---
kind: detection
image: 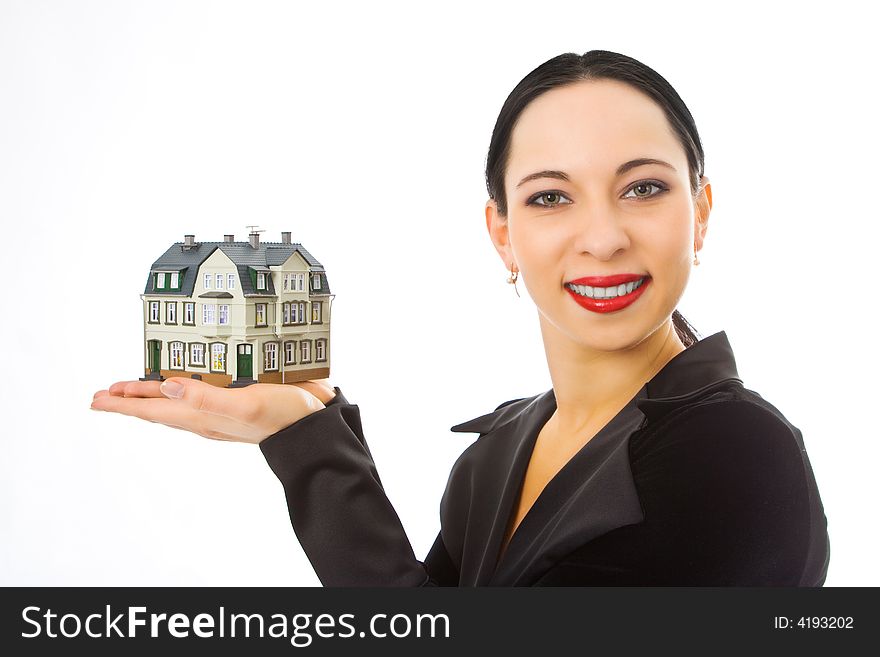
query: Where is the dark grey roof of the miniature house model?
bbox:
[144,242,330,297]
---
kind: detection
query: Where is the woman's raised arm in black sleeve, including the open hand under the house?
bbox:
[91,377,459,586]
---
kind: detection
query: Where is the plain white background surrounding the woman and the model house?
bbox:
[0,0,880,586]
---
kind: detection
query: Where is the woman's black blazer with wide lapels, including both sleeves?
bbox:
[260,331,830,586]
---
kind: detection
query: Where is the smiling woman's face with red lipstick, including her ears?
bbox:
[486,80,711,350]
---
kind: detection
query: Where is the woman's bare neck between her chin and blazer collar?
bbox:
[539,313,685,434]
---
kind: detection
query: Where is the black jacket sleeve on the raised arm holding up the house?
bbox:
[260,387,458,586]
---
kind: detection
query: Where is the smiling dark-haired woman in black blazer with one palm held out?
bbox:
[92,50,829,586]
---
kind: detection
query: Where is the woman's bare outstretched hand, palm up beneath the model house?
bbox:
[91,377,335,443]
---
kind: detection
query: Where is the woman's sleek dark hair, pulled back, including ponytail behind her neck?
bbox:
[486,50,704,347]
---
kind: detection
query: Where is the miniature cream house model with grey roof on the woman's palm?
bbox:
[141,232,333,387]
